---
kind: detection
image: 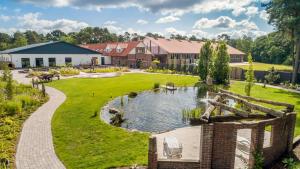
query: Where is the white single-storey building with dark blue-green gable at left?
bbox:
[0,41,111,68]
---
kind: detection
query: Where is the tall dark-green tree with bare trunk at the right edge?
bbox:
[266,0,300,83]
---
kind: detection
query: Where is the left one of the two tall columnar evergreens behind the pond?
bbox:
[198,41,213,81]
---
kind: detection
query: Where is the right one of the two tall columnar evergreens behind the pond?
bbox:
[213,42,230,84]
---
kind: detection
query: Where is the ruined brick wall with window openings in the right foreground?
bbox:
[149,113,296,169]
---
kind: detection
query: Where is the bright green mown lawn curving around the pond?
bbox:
[49,74,300,169]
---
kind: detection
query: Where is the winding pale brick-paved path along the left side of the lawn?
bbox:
[13,72,66,169]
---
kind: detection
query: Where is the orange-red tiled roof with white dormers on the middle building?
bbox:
[81,41,142,57]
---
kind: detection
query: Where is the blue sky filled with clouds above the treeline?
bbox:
[0,0,274,39]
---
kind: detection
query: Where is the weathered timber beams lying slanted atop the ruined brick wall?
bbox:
[199,89,294,124]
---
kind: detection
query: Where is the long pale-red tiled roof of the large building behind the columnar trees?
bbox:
[146,37,244,55]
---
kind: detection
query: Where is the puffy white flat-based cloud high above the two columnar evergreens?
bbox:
[193,16,236,29]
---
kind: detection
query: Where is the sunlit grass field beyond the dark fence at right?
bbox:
[232,62,293,72]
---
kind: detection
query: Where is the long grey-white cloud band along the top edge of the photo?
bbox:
[14,0,258,16]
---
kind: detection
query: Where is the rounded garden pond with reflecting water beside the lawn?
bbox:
[101,87,223,132]
